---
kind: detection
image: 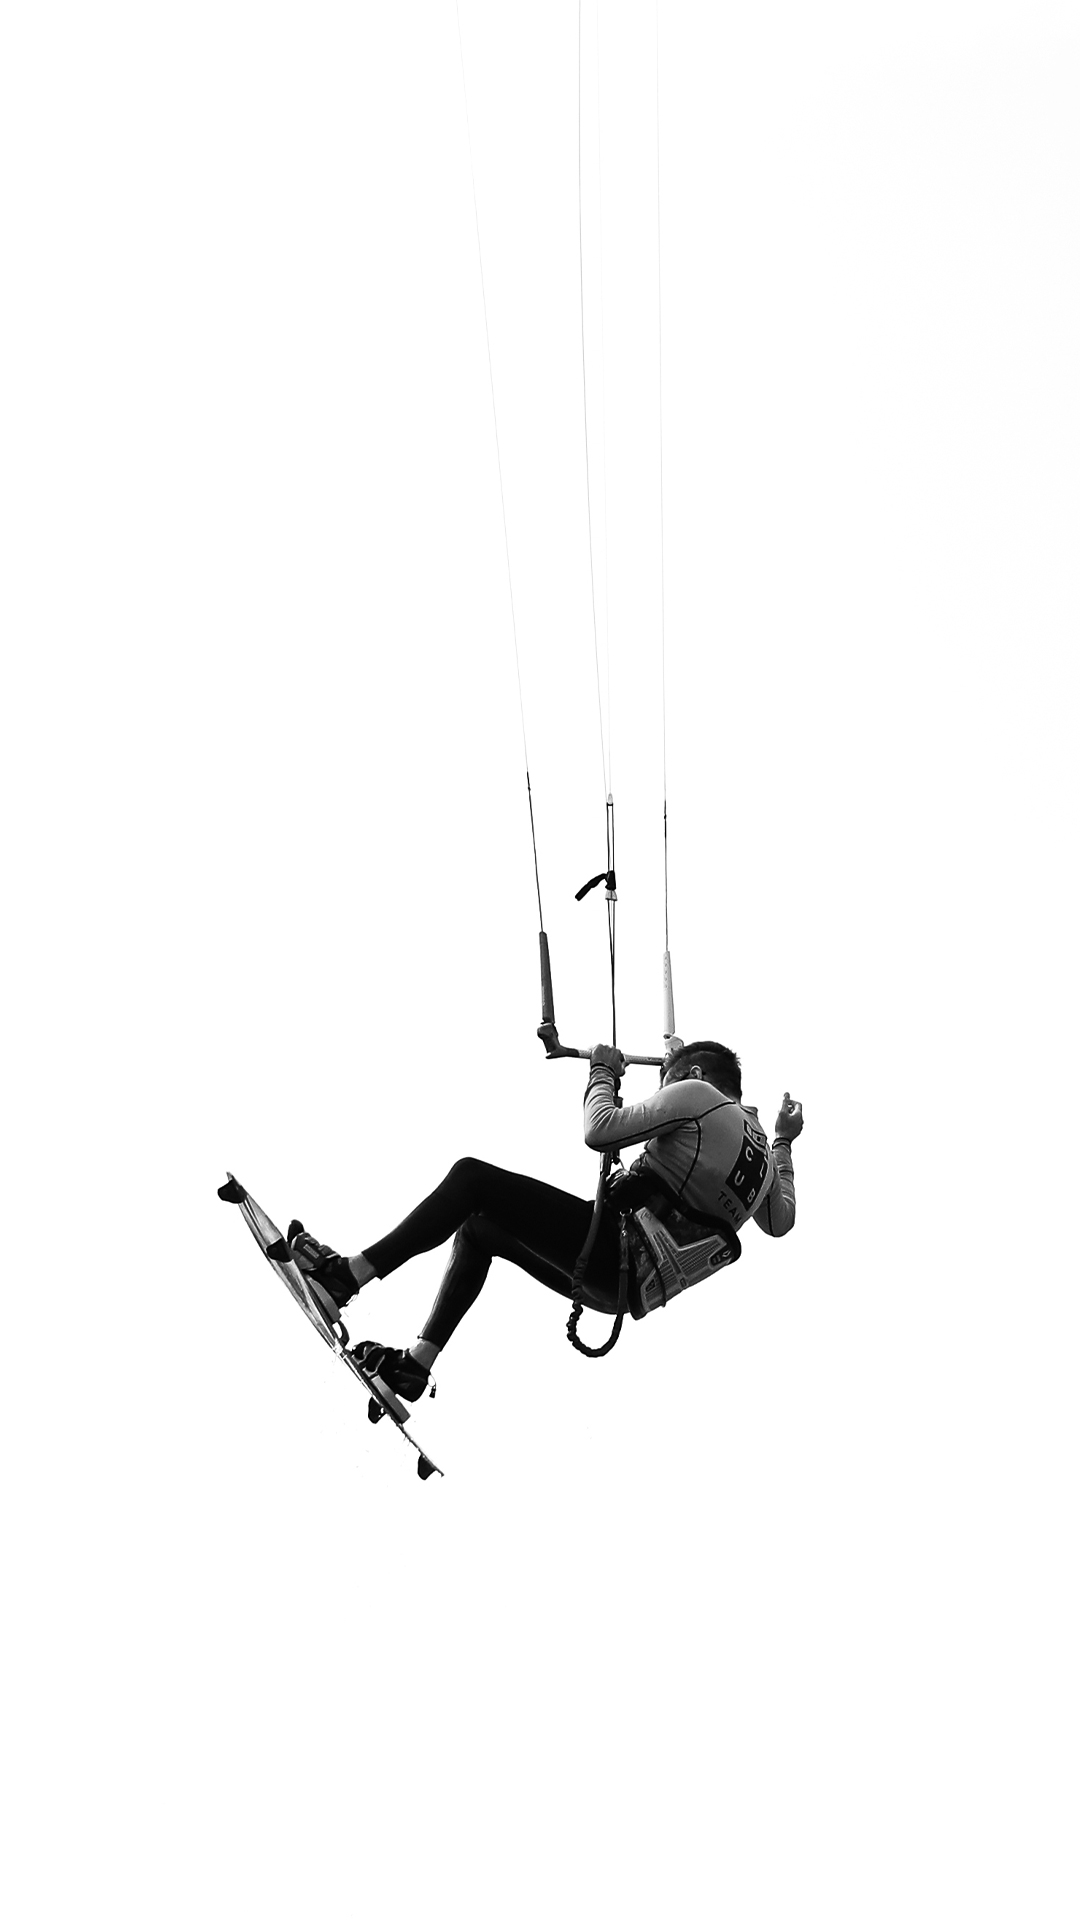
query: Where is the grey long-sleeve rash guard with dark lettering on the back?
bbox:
[584,1066,796,1236]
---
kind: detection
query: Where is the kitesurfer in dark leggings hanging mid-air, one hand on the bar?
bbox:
[288,1041,803,1400]
